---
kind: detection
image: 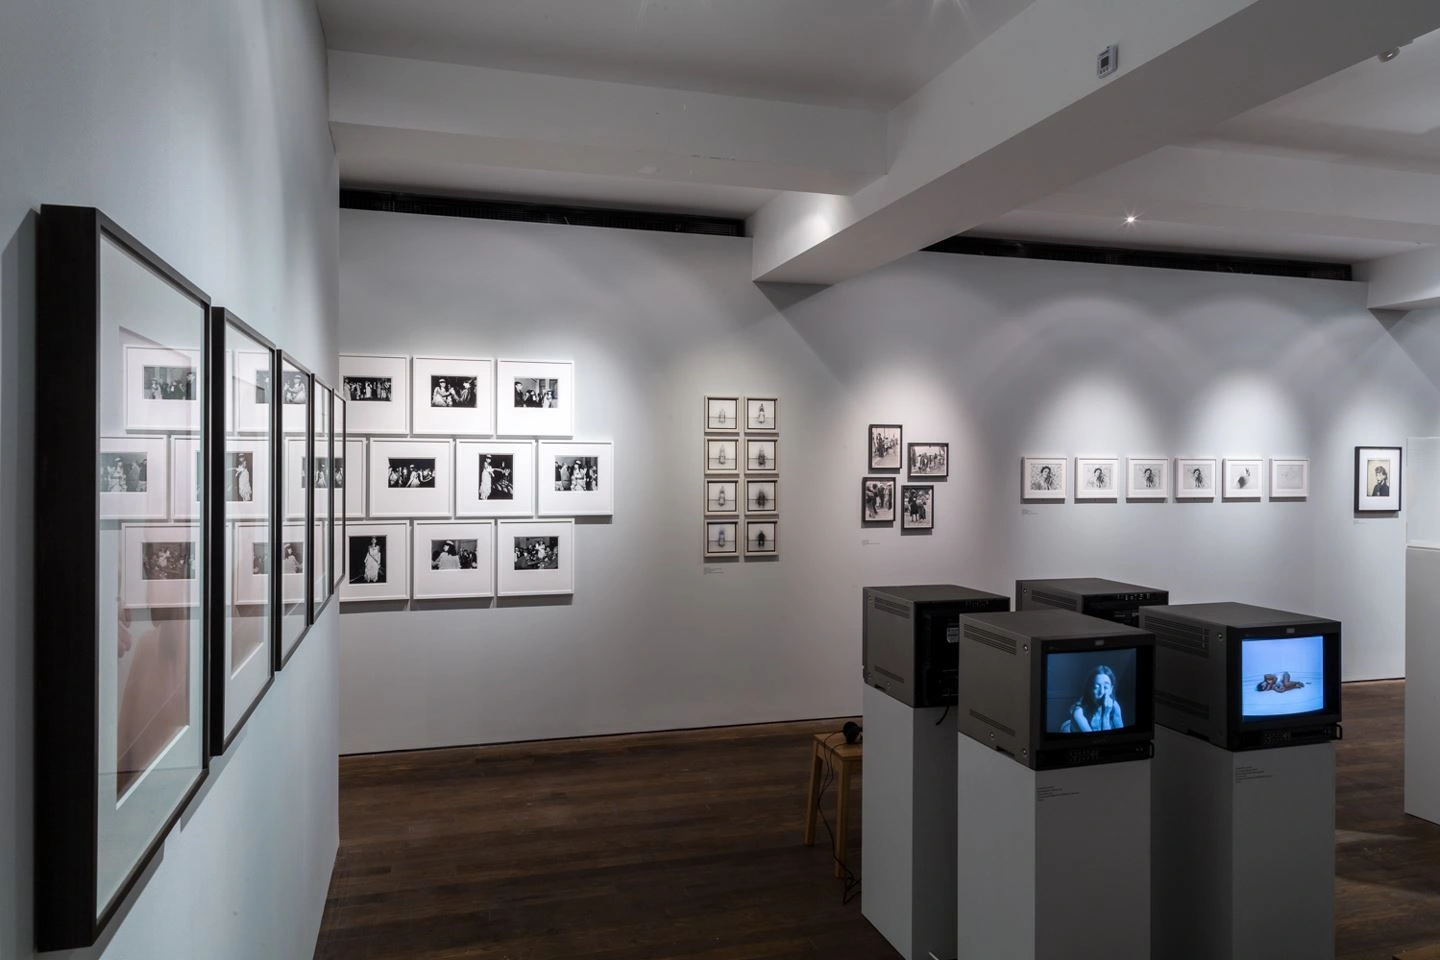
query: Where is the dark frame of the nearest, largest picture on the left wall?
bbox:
[35,204,216,953]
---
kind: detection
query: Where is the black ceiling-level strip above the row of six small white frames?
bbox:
[924,236,1354,281]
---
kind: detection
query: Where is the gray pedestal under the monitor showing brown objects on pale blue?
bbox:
[1152,727,1335,960]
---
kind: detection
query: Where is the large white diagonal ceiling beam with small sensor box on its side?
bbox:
[750,0,1440,284]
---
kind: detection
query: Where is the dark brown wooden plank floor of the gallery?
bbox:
[315,682,1440,960]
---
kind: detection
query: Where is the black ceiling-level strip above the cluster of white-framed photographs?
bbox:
[340,187,744,236]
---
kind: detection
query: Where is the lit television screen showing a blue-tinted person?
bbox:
[1045,649,1138,734]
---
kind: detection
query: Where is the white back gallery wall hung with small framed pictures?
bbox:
[340,210,1440,753]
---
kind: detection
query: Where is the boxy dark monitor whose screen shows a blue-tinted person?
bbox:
[958,610,1155,770]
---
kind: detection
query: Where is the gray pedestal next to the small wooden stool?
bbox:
[860,687,955,960]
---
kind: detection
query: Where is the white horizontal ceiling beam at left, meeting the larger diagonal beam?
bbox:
[330,50,886,193]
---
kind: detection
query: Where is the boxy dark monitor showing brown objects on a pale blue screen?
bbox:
[1140,603,1341,750]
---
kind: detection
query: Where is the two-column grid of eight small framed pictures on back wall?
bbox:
[701,396,780,560]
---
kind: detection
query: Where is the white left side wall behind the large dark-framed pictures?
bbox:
[0,0,338,960]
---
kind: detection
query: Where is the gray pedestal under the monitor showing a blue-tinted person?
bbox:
[956,735,1146,960]
